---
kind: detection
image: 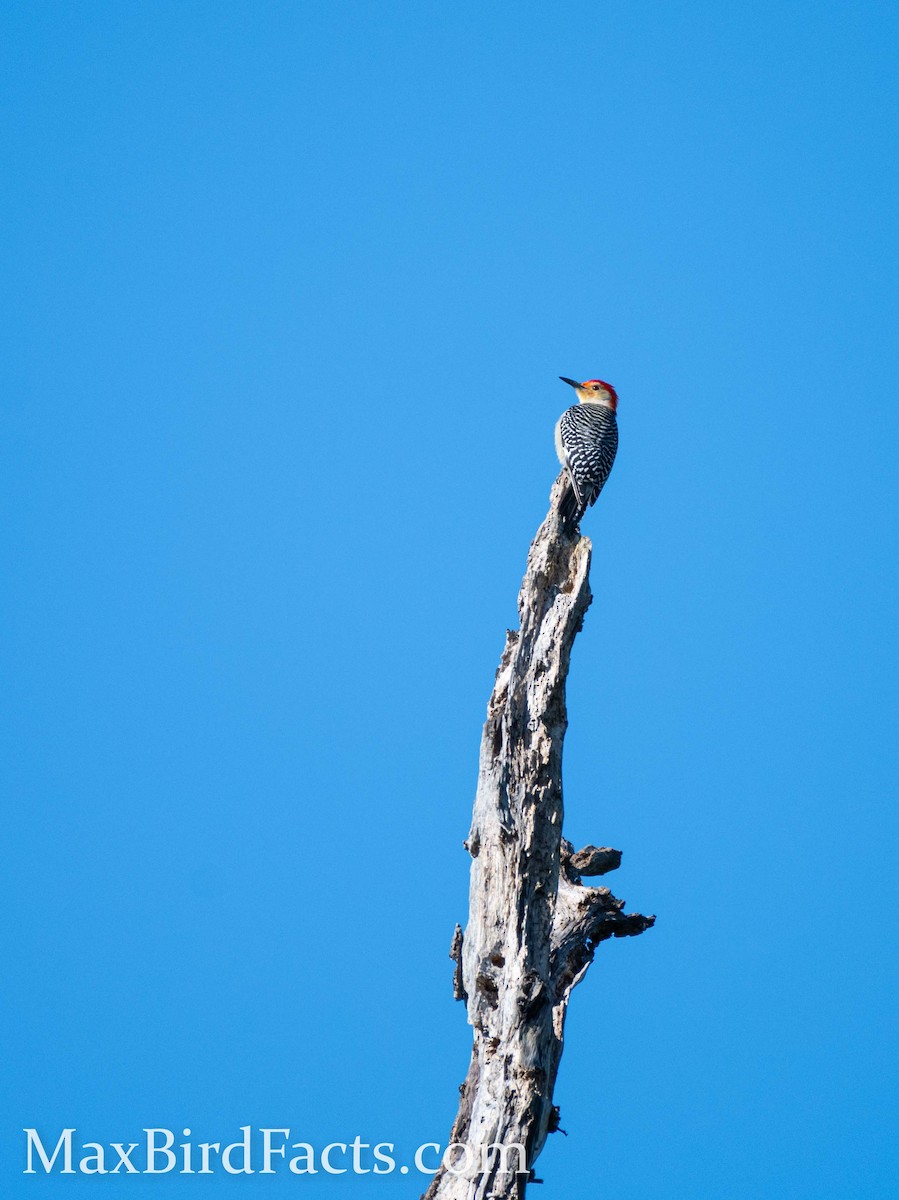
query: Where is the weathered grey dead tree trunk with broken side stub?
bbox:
[426,475,654,1200]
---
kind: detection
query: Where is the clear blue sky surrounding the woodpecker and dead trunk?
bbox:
[0,0,899,1200]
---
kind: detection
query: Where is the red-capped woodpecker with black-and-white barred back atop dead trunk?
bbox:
[556,376,618,534]
